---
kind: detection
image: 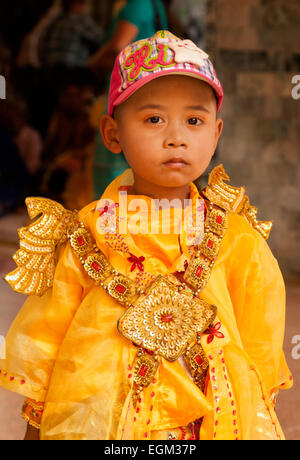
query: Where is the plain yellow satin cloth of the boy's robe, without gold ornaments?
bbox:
[0,170,292,440]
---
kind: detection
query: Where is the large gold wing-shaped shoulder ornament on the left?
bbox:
[4,197,79,296]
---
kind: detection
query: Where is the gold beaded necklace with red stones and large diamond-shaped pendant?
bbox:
[70,199,228,404]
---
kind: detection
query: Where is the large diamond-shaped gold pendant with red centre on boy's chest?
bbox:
[118,276,217,361]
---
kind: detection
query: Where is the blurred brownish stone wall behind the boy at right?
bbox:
[206,0,300,276]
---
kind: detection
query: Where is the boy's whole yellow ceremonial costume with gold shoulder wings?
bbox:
[0,167,292,440]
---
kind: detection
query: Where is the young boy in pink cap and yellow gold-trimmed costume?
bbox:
[0,31,292,440]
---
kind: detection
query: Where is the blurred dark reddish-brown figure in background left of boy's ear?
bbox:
[41,76,96,209]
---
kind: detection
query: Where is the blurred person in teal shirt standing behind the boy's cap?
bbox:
[89,0,169,197]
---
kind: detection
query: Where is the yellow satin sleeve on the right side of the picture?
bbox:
[229,215,292,397]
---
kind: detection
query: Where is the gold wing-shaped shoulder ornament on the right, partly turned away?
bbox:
[203,164,272,240]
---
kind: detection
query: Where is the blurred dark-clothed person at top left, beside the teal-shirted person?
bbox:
[39,0,104,137]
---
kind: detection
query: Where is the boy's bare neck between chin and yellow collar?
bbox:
[130,177,190,206]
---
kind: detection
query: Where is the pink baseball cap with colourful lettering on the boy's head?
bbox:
[108,30,224,115]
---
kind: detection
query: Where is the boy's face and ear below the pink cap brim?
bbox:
[101,75,223,193]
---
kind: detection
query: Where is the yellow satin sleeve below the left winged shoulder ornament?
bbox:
[0,242,87,402]
